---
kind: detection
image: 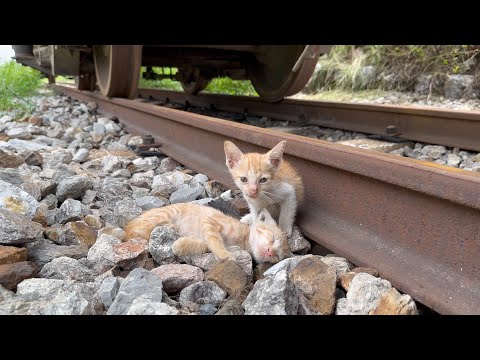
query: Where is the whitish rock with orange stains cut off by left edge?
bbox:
[0,180,38,219]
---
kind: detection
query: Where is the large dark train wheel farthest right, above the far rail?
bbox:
[247,45,321,102]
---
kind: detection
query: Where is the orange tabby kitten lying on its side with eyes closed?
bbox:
[125,203,293,263]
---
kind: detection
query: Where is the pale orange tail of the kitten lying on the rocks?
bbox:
[125,208,173,240]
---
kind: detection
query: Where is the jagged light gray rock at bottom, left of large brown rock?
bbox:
[246,270,299,315]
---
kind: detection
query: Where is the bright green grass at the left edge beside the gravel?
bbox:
[0,61,41,117]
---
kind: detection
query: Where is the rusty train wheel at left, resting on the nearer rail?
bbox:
[93,45,142,98]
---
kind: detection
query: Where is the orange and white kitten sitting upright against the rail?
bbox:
[224,141,304,237]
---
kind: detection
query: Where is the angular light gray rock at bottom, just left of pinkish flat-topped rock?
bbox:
[107,268,162,315]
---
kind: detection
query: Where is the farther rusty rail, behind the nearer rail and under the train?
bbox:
[139,89,480,151]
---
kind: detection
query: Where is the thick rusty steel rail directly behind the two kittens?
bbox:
[57,86,480,314]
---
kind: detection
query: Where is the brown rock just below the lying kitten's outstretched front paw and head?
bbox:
[205,260,251,302]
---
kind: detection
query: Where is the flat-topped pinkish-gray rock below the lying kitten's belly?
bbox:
[151,264,205,294]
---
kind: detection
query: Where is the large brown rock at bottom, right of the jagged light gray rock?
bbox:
[290,257,337,315]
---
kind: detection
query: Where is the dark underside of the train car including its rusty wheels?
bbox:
[13,45,331,102]
